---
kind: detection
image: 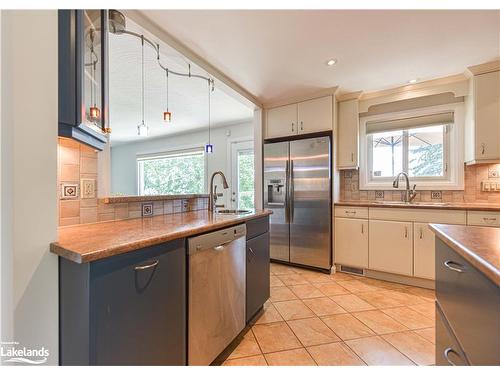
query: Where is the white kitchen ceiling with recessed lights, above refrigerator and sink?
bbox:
[141,10,500,103]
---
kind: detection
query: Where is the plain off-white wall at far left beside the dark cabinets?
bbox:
[1,10,58,365]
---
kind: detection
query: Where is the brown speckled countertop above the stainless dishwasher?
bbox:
[50,210,272,263]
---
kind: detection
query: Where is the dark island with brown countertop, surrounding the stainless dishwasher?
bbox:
[51,210,271,365]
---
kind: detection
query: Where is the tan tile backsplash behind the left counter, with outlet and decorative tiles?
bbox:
[57,138,208,226]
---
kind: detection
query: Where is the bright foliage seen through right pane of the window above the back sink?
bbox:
[409,143,443,176]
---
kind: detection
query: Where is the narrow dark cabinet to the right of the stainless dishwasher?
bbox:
[246,217,270,322]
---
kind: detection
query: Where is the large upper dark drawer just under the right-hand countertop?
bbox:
[436,239,500,365]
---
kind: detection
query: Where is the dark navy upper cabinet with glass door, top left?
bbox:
[58,9,109,150]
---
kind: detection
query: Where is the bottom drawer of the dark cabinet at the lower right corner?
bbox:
[436,303,469,366]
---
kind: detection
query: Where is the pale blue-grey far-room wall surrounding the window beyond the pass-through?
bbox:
[111,123,254,200]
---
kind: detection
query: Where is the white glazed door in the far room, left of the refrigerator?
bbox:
[230,141,255,210]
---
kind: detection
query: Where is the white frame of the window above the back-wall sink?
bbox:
[359,102,465,190]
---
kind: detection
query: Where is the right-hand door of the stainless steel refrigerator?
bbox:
[289,137,331,269]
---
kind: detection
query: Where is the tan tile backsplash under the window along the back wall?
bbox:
[340,164,500,204]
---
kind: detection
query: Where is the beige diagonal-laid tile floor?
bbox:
[223,263,435,366]
